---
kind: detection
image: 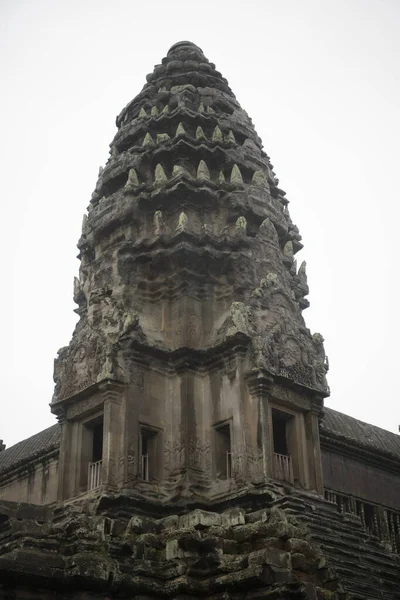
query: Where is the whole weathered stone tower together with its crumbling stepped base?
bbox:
[0,42,400,600]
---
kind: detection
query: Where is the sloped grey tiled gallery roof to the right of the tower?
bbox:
[321,408,400,460]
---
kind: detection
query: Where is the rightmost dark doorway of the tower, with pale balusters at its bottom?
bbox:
[272,409,295,484]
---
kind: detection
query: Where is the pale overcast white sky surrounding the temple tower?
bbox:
[0,0,400,446]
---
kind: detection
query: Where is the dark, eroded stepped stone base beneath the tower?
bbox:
[0,495,398,600]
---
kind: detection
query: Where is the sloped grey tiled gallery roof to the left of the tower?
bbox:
[0,423,60,474]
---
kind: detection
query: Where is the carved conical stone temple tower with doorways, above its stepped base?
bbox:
[52,42,329,505]
